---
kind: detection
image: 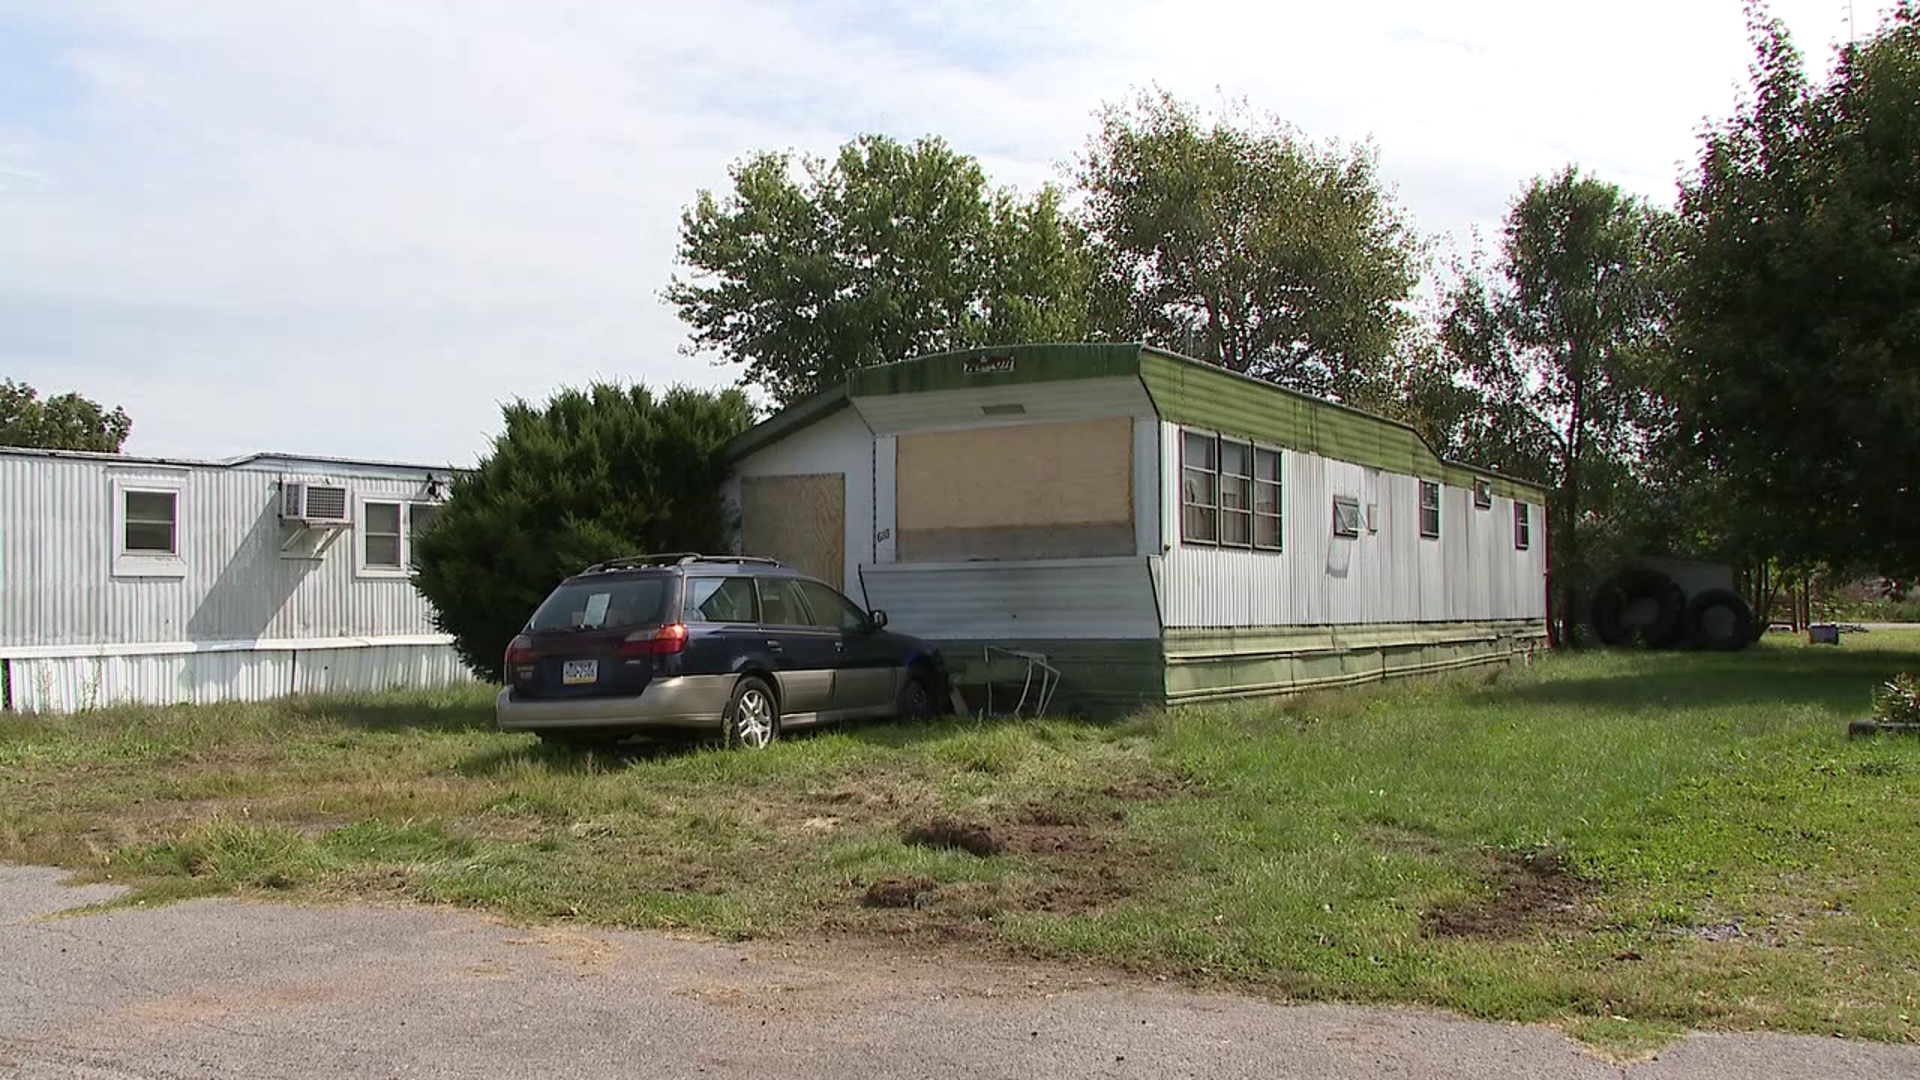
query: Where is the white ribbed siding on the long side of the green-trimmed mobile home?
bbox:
[1162,425,1546,626]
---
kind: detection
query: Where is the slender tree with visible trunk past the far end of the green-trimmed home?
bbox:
[1442,169,1668,640]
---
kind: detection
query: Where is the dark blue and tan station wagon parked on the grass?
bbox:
[493,553,947,748]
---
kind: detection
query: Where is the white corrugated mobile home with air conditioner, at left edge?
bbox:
[0,448,468,711]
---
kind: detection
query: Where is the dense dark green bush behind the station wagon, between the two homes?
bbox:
[413,384,753,680]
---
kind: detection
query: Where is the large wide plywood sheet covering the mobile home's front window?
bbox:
[895,417,1135,563]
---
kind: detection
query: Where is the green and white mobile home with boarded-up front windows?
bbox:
[730,344,1546,711]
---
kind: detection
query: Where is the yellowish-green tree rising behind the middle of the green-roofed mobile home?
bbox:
[1079,92,1421,398]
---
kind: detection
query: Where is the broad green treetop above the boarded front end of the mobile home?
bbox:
[664,135,1091,404]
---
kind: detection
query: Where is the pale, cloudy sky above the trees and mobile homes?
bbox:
[0,0,1876,465]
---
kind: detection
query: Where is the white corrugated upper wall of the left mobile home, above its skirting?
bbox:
[0,455,434,650]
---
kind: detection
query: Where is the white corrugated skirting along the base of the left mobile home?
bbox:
[10,646,472,713]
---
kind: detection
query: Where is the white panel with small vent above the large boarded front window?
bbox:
[856,375,1156,438]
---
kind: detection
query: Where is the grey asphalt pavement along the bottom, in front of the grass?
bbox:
[0,867,1920,1080]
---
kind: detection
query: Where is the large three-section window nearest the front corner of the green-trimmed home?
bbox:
[1181,430,1283,552]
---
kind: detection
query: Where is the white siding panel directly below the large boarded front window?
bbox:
[860,557,1160,640]
